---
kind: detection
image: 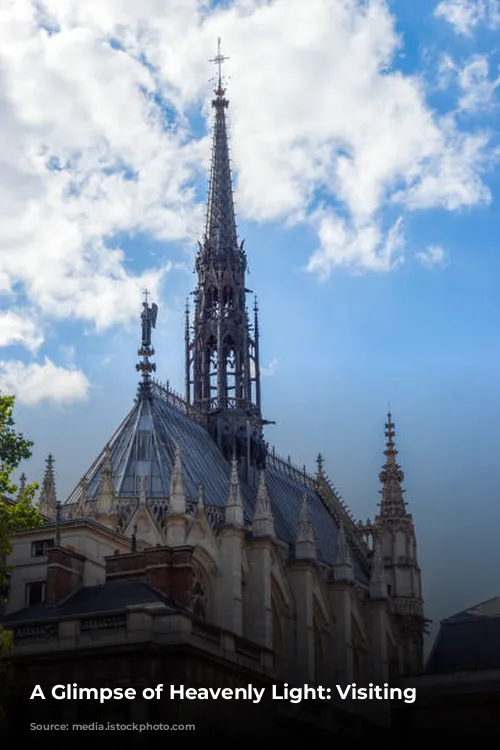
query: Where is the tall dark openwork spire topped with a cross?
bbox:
[186,40,266,485]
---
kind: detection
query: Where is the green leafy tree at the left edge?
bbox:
[0,395,43,659]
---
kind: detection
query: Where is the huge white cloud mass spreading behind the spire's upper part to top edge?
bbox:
[0,0,490,320]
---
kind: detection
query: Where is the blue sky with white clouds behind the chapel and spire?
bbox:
[0,0,500,648]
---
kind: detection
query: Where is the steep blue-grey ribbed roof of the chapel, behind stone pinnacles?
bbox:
[61,388,368,584]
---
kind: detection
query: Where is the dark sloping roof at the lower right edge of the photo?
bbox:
[425,597,500,675]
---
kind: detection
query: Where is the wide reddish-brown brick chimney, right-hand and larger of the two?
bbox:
[105,546,194,605]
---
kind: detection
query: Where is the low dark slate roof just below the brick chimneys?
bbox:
[1,580,179,626]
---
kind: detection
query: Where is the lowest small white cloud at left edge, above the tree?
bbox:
[0,358,90,406]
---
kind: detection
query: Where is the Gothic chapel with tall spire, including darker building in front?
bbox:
[1,42,425,748]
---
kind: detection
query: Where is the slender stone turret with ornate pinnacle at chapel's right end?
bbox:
[374,412,426,672]
